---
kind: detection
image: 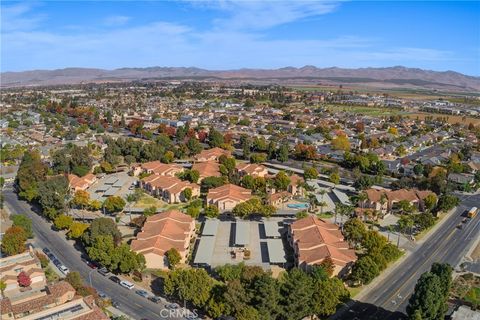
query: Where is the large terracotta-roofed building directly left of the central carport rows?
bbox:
[130,210,195,269]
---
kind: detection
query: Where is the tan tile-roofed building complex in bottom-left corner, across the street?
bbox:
[0,250,109,320]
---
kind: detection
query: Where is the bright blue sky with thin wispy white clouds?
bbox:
[1,0,480,76]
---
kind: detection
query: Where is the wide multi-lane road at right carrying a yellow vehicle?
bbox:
[332,195,480,320]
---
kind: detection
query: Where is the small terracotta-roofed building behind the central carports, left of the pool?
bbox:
[207,184,252,212]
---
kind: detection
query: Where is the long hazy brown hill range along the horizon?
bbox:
[0,66,480,92]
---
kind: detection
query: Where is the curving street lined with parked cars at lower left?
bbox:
[2,188,186,319]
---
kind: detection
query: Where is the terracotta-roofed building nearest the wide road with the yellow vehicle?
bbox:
[358,189,434,214]
